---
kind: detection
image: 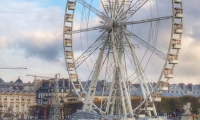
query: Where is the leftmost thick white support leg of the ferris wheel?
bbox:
[83,35,109,112]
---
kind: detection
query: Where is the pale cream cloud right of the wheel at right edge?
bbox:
[177,36,200,77]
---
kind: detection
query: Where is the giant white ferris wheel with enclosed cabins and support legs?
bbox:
[63,0,183,119]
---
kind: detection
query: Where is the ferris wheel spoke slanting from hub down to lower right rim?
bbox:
[125,30,167,60]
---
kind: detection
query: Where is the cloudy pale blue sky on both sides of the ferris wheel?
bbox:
[0,0,200,84]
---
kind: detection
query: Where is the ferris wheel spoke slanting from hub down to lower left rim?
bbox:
[71,31,106,68]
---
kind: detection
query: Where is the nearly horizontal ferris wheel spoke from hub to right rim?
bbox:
[120,16,173,25]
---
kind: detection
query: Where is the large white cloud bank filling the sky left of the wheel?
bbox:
[0,0,67,81]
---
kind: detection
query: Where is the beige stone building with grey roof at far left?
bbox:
[0,78,35,118]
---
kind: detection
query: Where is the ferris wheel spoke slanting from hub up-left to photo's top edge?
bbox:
[77,0,106,20]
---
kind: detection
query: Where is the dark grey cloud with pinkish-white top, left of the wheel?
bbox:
[13,31,64,61]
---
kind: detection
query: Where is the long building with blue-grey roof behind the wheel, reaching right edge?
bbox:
[82,81,200,100]
